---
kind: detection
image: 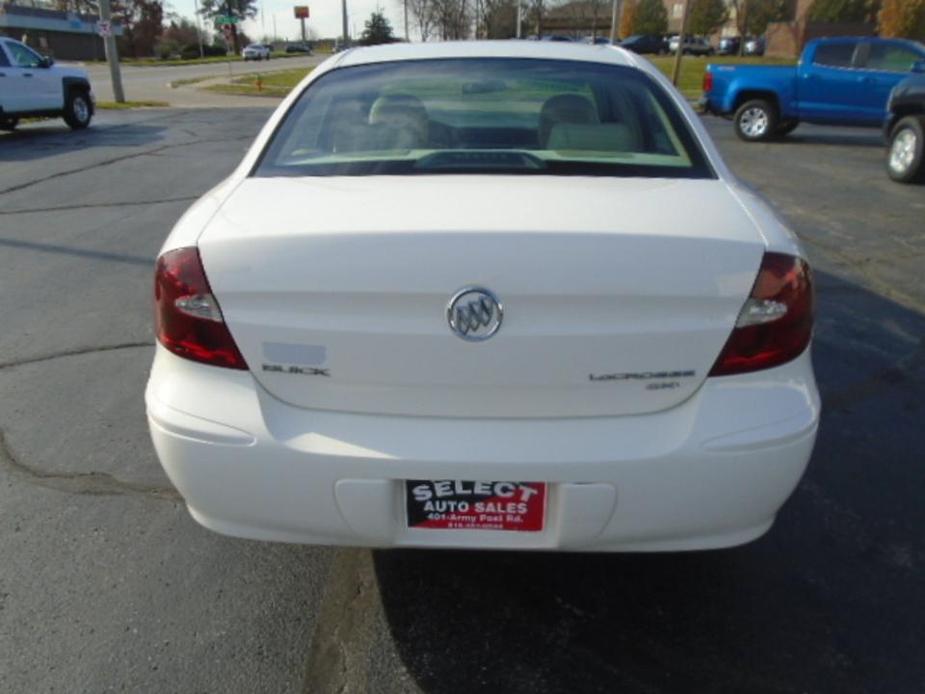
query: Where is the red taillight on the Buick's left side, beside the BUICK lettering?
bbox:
[154,248,247,369]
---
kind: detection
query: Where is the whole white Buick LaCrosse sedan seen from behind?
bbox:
[146,41,819,551]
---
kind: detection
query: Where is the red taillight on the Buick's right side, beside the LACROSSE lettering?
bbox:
[710,253,813,376]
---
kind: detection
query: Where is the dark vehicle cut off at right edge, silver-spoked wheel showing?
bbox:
[885,61,925,183]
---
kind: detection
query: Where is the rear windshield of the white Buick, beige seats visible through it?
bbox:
[255,58,713,178]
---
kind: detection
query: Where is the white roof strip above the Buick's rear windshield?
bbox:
[337,39,641,67]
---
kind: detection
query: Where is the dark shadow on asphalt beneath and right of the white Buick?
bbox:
[374,274,925,694]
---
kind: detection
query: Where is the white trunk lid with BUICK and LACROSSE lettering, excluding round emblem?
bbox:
[199,176,764,417]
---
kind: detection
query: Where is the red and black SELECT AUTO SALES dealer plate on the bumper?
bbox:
[405,480,546,532]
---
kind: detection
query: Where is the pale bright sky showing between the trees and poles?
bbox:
[170,0,405,40]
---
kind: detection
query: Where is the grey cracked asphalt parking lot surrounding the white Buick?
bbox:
[0,108,925,694]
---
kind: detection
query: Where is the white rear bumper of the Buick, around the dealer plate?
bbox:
[146,347,819,551]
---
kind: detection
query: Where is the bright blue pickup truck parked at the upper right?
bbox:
[701,37,925,142]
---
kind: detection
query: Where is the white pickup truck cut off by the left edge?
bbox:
[0,36,95,130]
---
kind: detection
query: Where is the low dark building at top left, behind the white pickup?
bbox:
[0,0,122,60]
